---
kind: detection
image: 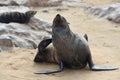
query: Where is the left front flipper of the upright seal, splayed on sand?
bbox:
[35,62,64,74]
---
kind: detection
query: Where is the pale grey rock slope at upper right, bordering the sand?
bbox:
[85,3,120,23]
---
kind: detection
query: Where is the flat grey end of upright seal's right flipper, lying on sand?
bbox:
[90,65,118,71]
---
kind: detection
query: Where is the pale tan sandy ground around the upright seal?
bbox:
[0,0,120,80]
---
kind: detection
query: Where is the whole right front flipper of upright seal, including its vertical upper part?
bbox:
[88,54,118,71]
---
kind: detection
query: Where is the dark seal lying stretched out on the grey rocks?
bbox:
[0,11,36,23]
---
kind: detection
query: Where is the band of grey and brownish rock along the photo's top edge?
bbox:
[0,0,86,7]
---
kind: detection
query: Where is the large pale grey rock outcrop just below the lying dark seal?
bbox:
[0,7,52,50]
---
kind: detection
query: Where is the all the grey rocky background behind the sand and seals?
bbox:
[0,0,120,51]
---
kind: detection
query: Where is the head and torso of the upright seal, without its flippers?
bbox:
[52,15,90,68]
